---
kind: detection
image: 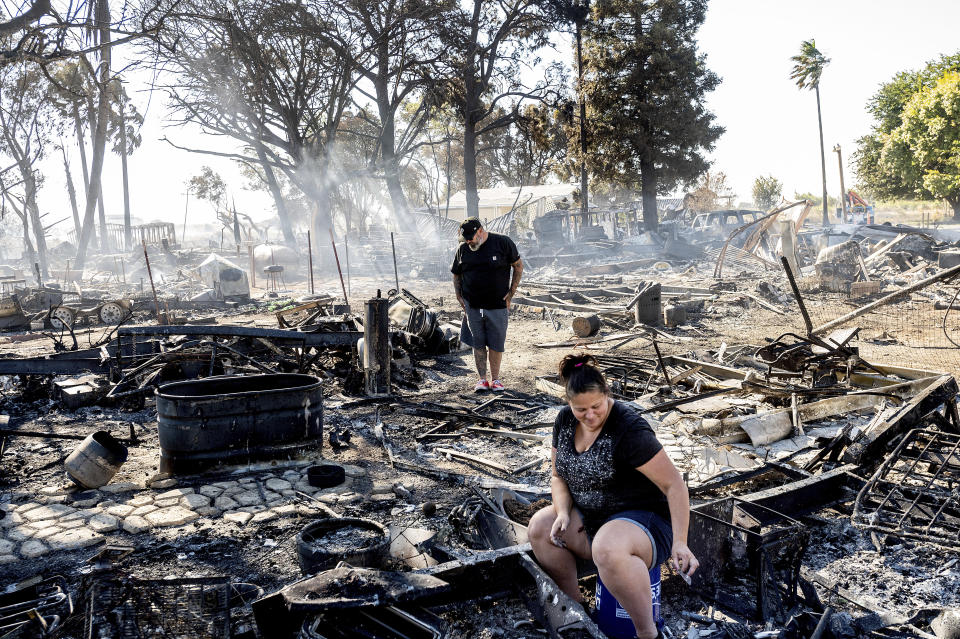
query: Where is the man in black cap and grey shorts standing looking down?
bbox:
[450,218,523,392]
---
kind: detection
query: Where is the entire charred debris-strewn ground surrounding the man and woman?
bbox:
[0,206,960,639]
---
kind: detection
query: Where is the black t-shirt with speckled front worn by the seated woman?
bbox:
[553,401,670,535]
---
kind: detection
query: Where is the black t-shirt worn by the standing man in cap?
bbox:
[450,233,520,308]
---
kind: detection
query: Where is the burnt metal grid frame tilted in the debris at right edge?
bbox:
[853,429,960,551]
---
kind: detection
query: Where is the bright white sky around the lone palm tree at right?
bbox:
[700,0,960,201]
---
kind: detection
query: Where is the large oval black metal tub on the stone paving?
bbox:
[156,374,323,473]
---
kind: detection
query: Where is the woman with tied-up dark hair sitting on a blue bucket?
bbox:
[528,355,700,639]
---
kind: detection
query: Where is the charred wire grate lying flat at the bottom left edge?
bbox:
[84,577,230,639]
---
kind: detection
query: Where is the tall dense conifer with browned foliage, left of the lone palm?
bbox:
[584,0,724,229]
